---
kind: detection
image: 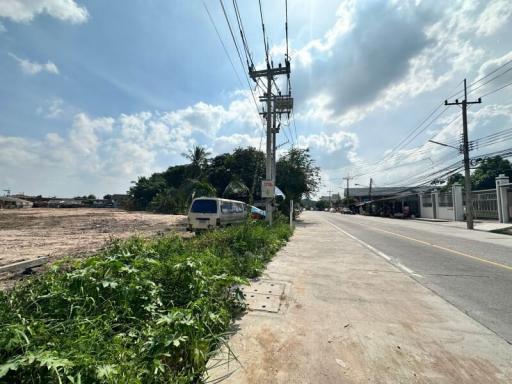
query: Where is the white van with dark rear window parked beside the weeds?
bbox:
[187,197,248,231]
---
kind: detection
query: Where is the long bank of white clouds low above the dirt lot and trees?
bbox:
[0,93,260,196]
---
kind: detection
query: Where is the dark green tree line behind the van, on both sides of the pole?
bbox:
[127,146,320,214]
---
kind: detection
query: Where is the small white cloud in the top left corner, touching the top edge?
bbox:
[0,0,89,24]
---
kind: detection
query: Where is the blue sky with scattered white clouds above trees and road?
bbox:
[0,0,512,196]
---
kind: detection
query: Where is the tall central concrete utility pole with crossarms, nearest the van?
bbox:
[249,58,293,224]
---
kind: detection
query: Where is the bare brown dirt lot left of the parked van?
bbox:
[0,208,186,266]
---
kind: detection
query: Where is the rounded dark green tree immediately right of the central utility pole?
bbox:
[276,148,320,214]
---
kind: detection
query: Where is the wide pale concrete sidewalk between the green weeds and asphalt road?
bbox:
[207,216,512,384]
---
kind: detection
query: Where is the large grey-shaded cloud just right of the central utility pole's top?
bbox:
[293,2,431,120]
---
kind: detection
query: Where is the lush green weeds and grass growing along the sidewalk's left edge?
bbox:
[0,222,291,384]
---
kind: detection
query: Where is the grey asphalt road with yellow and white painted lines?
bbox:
[322,212,512,344]
